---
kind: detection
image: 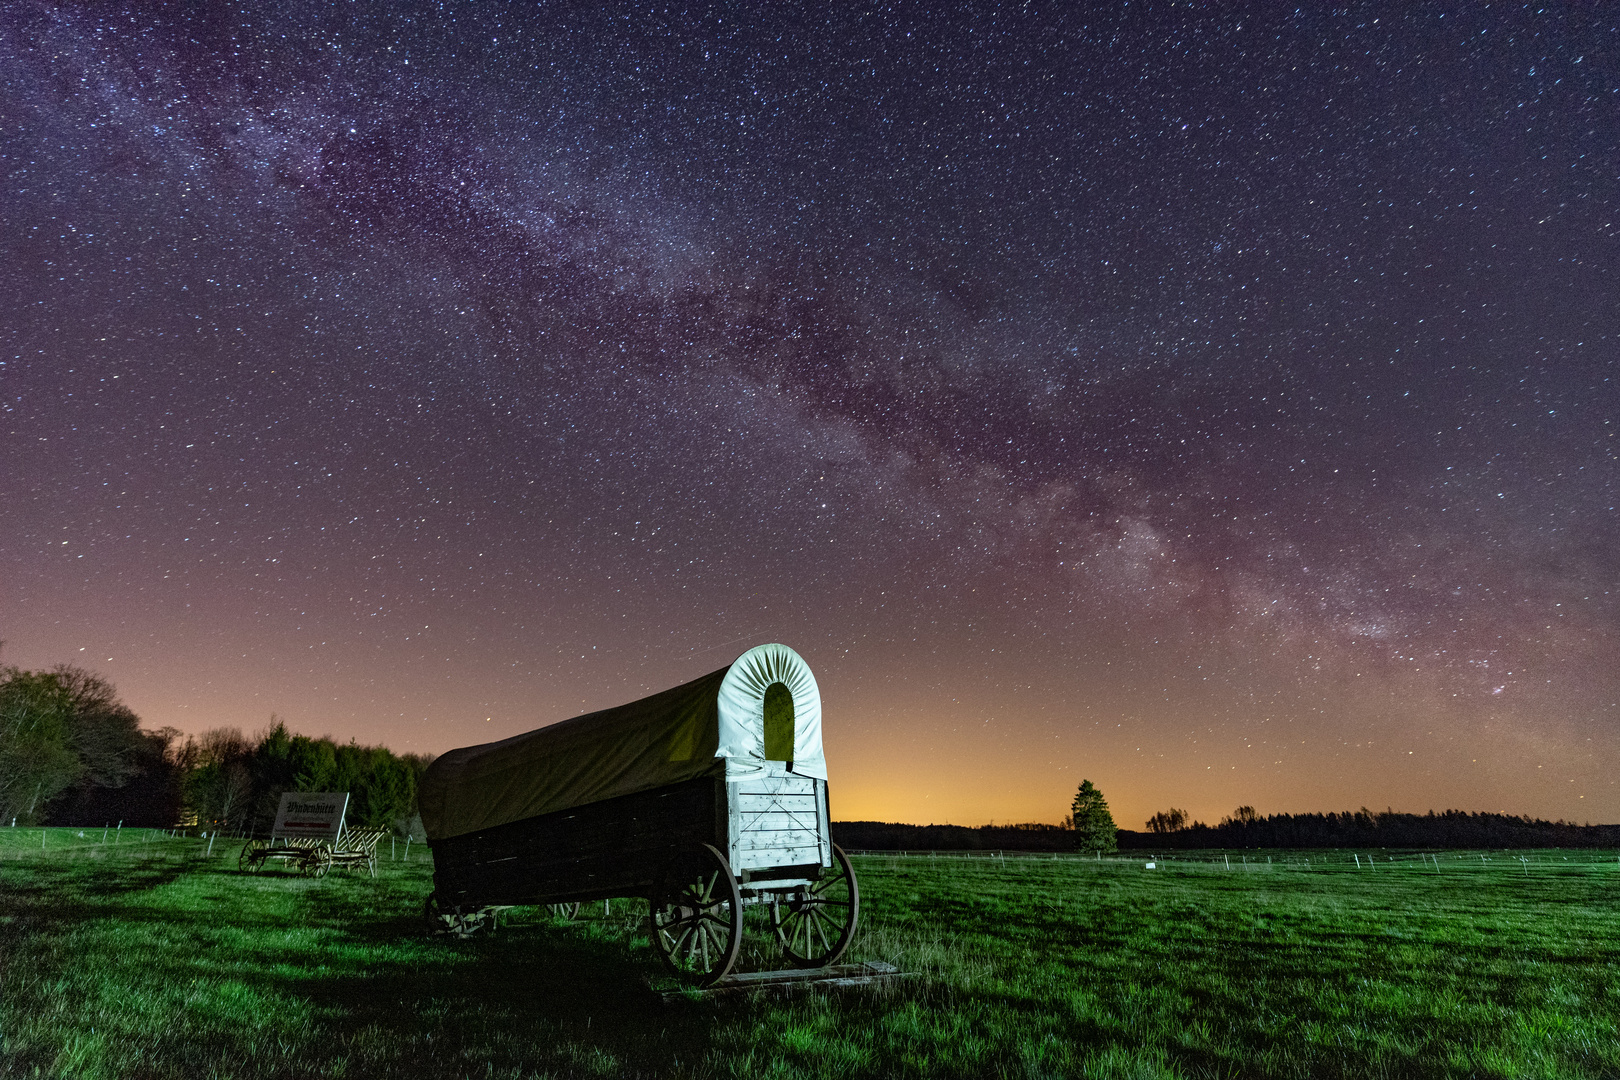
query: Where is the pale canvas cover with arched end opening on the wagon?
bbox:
[420,644,826,840]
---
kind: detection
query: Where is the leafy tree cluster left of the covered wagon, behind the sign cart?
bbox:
[0,664,431,836]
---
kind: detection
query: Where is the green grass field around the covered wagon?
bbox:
[0,829,1620,1077]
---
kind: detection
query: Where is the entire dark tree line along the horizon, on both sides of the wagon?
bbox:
[0,664,1620,852]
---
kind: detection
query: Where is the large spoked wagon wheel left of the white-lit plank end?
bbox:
[648,844,742,986]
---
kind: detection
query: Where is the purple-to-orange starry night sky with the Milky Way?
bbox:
[0,0,1620,827]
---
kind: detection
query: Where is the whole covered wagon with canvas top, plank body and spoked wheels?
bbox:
[420,644,860,984]
